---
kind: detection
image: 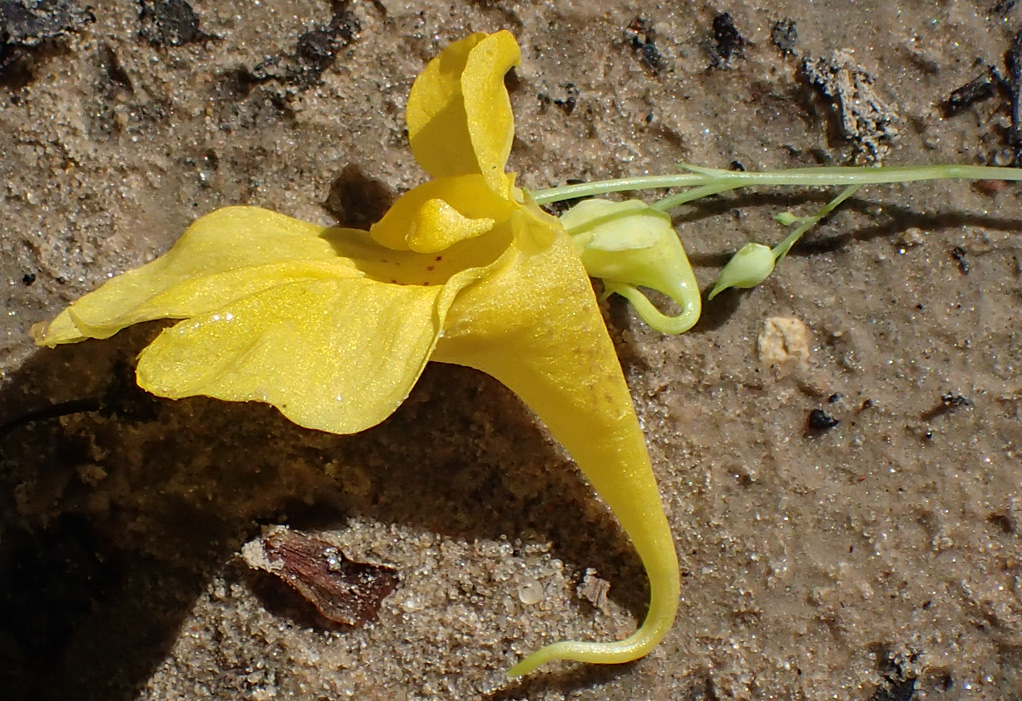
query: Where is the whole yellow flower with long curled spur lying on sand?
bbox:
[34,32,680,675]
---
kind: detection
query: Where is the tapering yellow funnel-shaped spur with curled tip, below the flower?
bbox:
[433,208,680,675]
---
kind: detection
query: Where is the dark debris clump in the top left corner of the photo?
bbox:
[0,0,96,85]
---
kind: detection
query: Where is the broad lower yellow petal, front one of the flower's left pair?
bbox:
[138,279,461,433]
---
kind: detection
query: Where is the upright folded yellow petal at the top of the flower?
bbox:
[406,31,520,198]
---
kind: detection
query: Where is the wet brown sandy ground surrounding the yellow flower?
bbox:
[0,0,1022,701]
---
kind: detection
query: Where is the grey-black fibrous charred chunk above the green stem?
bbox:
[802,51,899,162]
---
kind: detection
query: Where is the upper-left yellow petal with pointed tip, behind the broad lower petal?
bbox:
[33,206,362,346]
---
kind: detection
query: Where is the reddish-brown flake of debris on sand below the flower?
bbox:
[242,526,399,625]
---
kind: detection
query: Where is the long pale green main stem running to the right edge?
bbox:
[532,166,1022,208]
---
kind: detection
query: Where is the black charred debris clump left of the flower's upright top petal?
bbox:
[251,3,362,90]
